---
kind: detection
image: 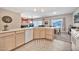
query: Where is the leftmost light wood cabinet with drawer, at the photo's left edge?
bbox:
[0,32,15,50]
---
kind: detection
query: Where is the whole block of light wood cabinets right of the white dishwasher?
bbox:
[33,28,54,40]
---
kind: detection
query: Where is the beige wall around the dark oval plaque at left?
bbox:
[0,9,21,30]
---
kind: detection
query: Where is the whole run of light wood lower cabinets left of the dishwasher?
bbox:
[0,31,24,51]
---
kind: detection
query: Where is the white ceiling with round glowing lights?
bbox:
[3,7,77,18]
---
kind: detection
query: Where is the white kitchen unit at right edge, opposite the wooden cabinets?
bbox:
[71,29,79,51]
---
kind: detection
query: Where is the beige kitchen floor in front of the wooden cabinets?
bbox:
[14,32,72,51]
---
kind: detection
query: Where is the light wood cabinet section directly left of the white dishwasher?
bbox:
[16,31,24,47]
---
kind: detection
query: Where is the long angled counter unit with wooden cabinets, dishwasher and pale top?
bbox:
[0,27,54,51]
